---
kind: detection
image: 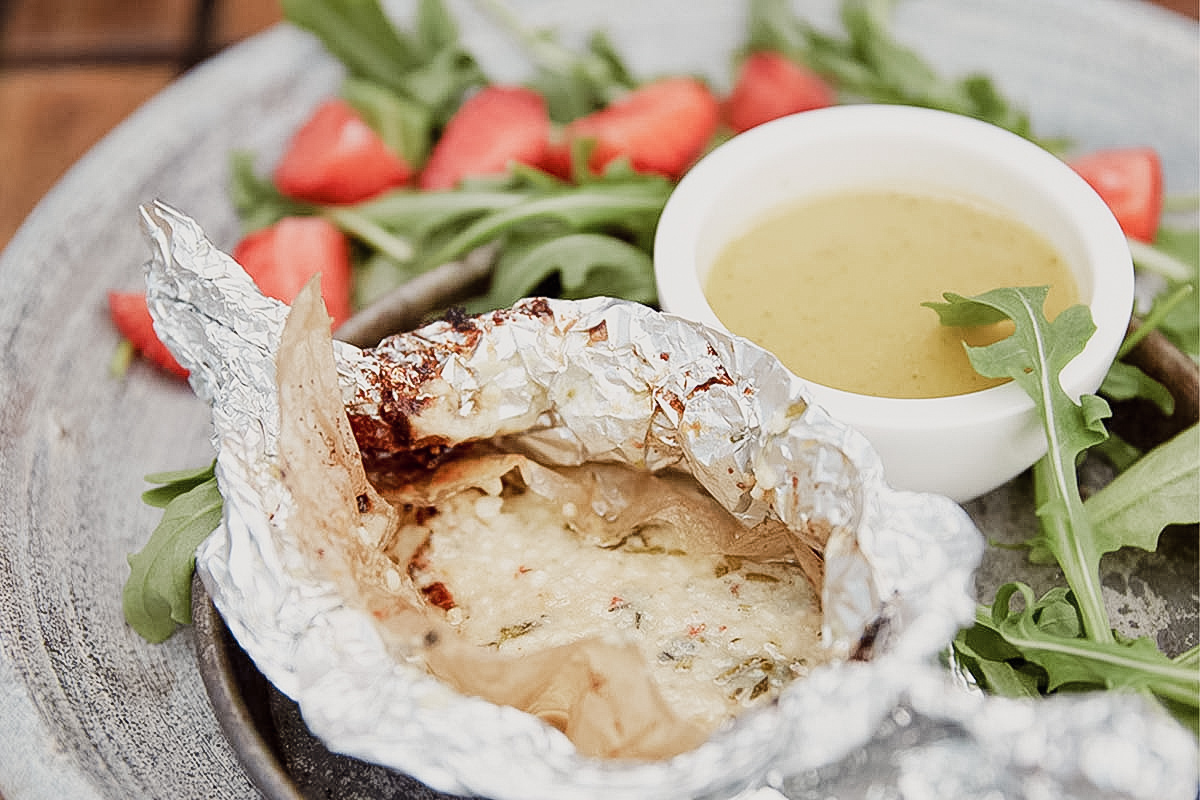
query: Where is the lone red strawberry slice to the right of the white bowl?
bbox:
[1067,148,1163,242]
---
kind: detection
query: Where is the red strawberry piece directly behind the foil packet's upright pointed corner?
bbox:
[233,217,353,327]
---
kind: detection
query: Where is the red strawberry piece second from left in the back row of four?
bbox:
[419,86,550,191]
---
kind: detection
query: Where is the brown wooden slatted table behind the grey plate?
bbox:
[0,0,1200,248]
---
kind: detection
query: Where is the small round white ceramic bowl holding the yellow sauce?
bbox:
[654,106,1133,501]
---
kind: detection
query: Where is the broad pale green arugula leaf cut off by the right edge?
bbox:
[1084,426,1200,553]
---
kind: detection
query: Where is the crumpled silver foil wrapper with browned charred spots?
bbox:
[143,204,1196,800]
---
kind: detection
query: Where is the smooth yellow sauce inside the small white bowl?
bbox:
[704,192,1078,397]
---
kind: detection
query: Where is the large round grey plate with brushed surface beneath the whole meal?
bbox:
[0,0,1200,800]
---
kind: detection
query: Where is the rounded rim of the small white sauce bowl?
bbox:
[654,103,1133,429]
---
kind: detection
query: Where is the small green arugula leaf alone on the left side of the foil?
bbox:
[121,465,223,642]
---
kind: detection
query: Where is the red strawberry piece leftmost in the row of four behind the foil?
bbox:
[275,98,413,204]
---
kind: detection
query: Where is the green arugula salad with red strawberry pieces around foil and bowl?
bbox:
[121,0,1200,732]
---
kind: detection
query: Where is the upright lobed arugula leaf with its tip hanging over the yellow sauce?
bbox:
[924,287,1112,642]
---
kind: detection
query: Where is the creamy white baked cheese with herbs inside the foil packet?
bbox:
[410,489,824,728]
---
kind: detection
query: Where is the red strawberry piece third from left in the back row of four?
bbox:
[547,77,720,180]
